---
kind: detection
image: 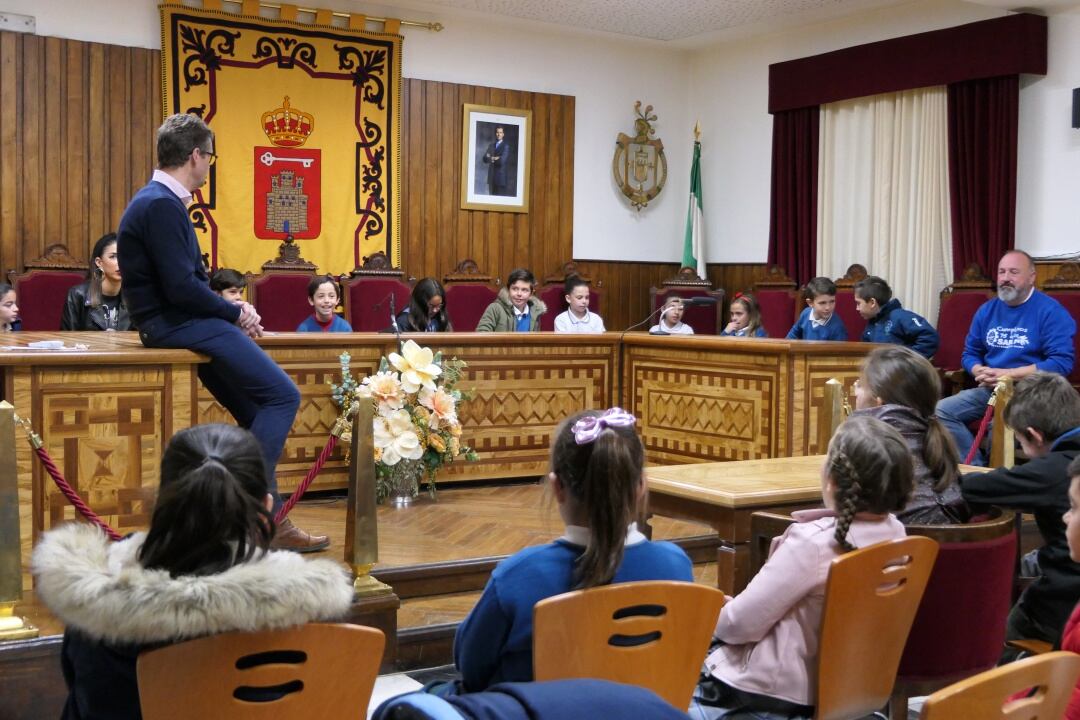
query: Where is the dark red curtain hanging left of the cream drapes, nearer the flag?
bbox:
[769,106,820,285]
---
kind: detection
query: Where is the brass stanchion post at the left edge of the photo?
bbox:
[0,402,39,642]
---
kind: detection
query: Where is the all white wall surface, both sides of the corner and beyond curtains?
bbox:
[8,0,1080,262]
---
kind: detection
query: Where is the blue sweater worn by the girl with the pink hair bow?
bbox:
[454,539,693,692]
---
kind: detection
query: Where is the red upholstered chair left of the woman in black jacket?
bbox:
[8,243,86,330]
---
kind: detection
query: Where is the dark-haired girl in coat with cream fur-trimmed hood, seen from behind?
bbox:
[31,425,352,720]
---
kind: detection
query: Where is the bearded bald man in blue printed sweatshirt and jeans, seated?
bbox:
[936,250,1077,465]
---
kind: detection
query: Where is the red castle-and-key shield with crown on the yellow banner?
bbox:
[254,96,322,240]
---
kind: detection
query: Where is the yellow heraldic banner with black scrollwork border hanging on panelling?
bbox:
[161,4,402,274]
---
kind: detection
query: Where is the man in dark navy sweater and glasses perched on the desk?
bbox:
[117,114,329,552]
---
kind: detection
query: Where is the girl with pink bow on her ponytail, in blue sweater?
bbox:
[449,408,693,692]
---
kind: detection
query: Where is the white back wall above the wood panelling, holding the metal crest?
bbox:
[0,0,693,264]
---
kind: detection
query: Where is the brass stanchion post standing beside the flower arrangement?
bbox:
[345,402,393,597]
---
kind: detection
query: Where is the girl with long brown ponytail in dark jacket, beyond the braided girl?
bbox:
[854,345,971,525]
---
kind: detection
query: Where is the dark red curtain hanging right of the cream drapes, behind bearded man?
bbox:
[948,76,1020,277]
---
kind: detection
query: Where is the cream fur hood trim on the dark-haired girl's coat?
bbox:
[31,522,353,644]
